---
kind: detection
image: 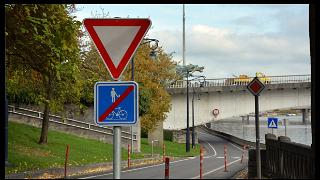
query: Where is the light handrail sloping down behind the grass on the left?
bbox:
[8,105,137,141]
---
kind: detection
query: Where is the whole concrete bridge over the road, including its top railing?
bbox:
[163,74,311,130]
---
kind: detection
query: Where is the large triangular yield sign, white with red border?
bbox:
[83,18,151,80]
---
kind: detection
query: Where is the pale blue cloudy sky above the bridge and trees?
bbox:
[75,4,311,79]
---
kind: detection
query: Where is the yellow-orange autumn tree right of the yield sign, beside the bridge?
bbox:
[124,44,178,131]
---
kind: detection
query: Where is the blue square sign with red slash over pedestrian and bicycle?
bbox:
[94,81,139,126]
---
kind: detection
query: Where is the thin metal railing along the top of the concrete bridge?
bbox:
[168,74,311,88]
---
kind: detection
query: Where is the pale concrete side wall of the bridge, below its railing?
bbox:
[163,83,311,130]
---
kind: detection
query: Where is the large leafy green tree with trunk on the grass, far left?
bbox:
[5,4,82,144]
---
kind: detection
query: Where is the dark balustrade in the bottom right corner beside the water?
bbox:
[265,134,315,179]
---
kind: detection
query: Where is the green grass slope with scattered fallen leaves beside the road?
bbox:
[5,122,199,174]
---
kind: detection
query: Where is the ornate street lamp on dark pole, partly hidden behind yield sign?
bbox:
[130,38,159,154]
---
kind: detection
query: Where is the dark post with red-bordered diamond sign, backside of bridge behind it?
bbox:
[247,77,265,179]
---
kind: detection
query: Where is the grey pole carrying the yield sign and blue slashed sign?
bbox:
[83,18,151,179]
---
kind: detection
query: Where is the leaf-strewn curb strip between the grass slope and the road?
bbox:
[5,157,188,179]
